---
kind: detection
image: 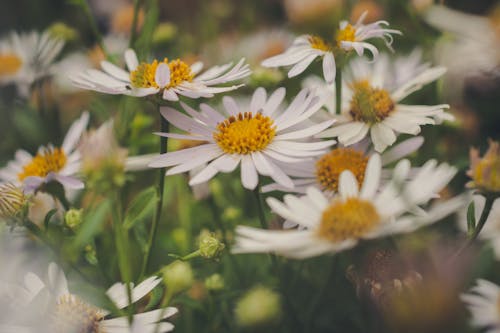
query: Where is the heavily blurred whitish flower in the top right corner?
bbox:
[424,5,500,98]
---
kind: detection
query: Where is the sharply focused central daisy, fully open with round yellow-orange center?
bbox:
[150,88,335,189]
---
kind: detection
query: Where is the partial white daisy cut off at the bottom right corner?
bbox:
[460,279,500,333]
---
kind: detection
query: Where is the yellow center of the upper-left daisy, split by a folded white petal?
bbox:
[130,58,194,89]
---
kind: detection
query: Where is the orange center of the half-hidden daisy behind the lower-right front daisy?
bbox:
[316,148,368,192]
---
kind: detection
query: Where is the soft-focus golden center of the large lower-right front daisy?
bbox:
[318,198,381,242]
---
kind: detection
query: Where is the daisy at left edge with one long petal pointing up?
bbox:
[0,112,89,192]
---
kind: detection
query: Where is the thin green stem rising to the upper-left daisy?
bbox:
[141,109,169,277]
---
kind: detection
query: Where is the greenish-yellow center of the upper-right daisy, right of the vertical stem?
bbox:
[349,80,394,124]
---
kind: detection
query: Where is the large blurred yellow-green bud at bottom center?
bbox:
[234,286,282,327]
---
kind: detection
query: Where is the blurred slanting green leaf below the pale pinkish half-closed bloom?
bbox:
[73,199,111,250]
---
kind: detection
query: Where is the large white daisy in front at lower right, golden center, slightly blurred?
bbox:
[233,154,463,259]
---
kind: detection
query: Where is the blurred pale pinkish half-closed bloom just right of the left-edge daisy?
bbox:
[79,120,127,191]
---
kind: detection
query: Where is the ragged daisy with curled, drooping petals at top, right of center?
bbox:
[262,12,401,83]
